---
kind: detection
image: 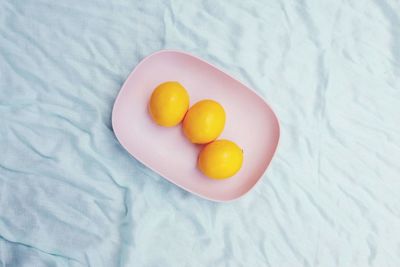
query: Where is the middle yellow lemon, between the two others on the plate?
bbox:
[183,100,225,144]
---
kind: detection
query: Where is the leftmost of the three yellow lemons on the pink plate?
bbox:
[149,82,189,127]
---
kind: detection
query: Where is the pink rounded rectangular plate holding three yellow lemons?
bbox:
[112,50,279,201]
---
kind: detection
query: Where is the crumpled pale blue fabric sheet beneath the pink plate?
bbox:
[0,0,400,267]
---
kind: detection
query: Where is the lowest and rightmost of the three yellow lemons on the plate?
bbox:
[197,140,243,179]
